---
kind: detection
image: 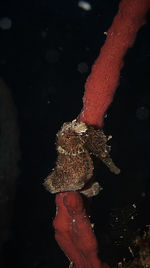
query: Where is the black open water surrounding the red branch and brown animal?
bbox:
[0,0,150,268]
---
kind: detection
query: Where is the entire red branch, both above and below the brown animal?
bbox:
[50,0,150,268]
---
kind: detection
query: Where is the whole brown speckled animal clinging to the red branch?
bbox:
[44,120,120,194]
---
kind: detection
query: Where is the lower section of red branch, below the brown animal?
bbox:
[53,192,109,268]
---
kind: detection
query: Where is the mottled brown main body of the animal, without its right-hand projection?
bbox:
[44,121,93,193]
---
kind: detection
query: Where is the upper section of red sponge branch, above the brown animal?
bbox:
[79,0,150,127]
